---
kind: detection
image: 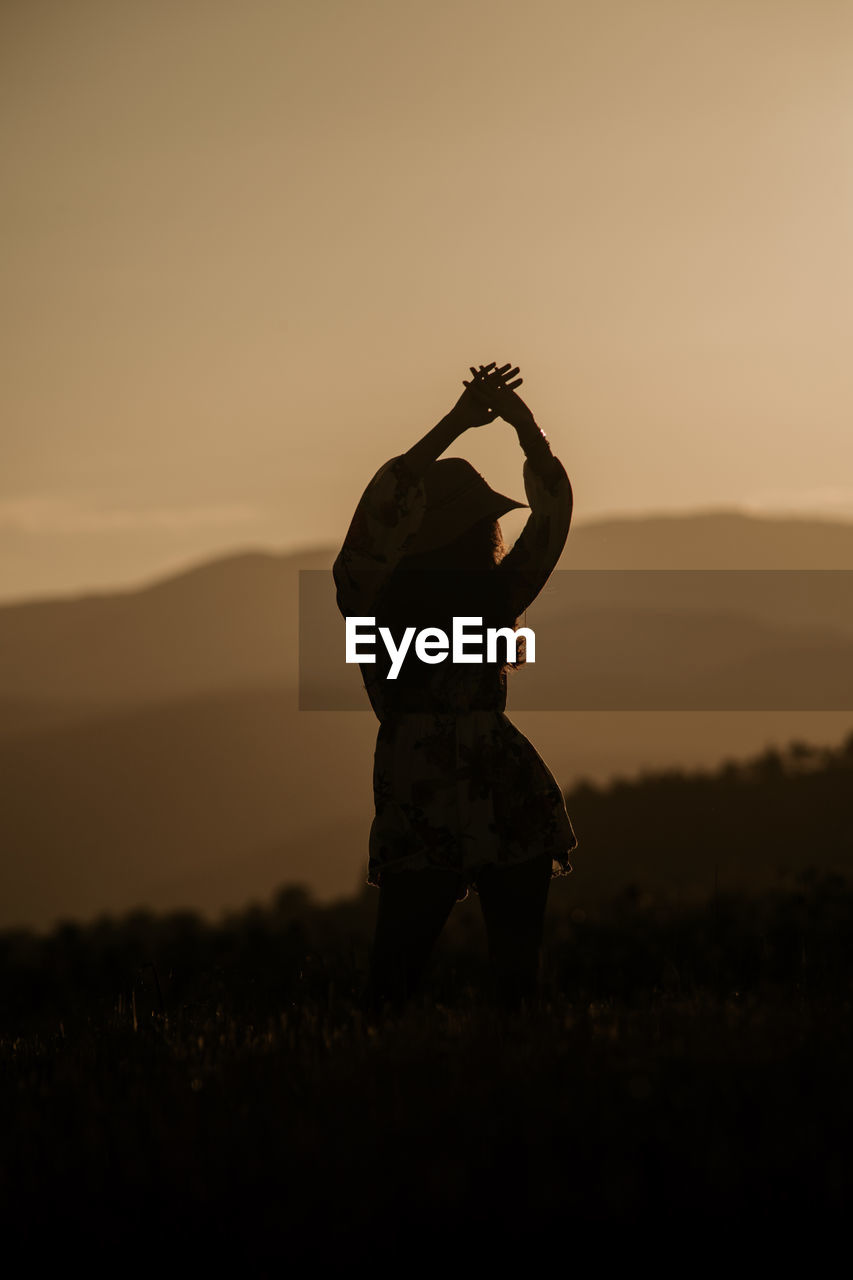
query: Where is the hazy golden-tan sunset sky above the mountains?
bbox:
[0,0,853,599]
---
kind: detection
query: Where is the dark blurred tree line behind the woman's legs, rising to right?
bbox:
[0,735,853,1030]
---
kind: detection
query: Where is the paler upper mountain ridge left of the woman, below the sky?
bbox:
[0,550,332,730]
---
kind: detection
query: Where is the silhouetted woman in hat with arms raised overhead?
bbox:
[333,361,578,1010]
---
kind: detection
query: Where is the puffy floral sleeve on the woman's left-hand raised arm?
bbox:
[332,454,427,617]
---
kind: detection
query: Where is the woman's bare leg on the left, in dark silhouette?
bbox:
[368,868,459,1012]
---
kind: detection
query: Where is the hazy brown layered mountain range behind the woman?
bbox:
[0,513,853,927]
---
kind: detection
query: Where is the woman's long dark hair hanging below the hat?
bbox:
[375,516,524,671]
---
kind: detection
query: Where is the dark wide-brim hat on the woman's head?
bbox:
[406,458,528,556]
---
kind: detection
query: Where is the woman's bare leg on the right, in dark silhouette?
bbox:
[476,854,552,1009]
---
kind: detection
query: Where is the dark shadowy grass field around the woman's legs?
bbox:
[0,873,853,1275]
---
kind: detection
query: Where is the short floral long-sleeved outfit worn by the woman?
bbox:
[333,453,578,901]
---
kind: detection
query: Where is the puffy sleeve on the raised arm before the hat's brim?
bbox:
[497,454,573,617]
